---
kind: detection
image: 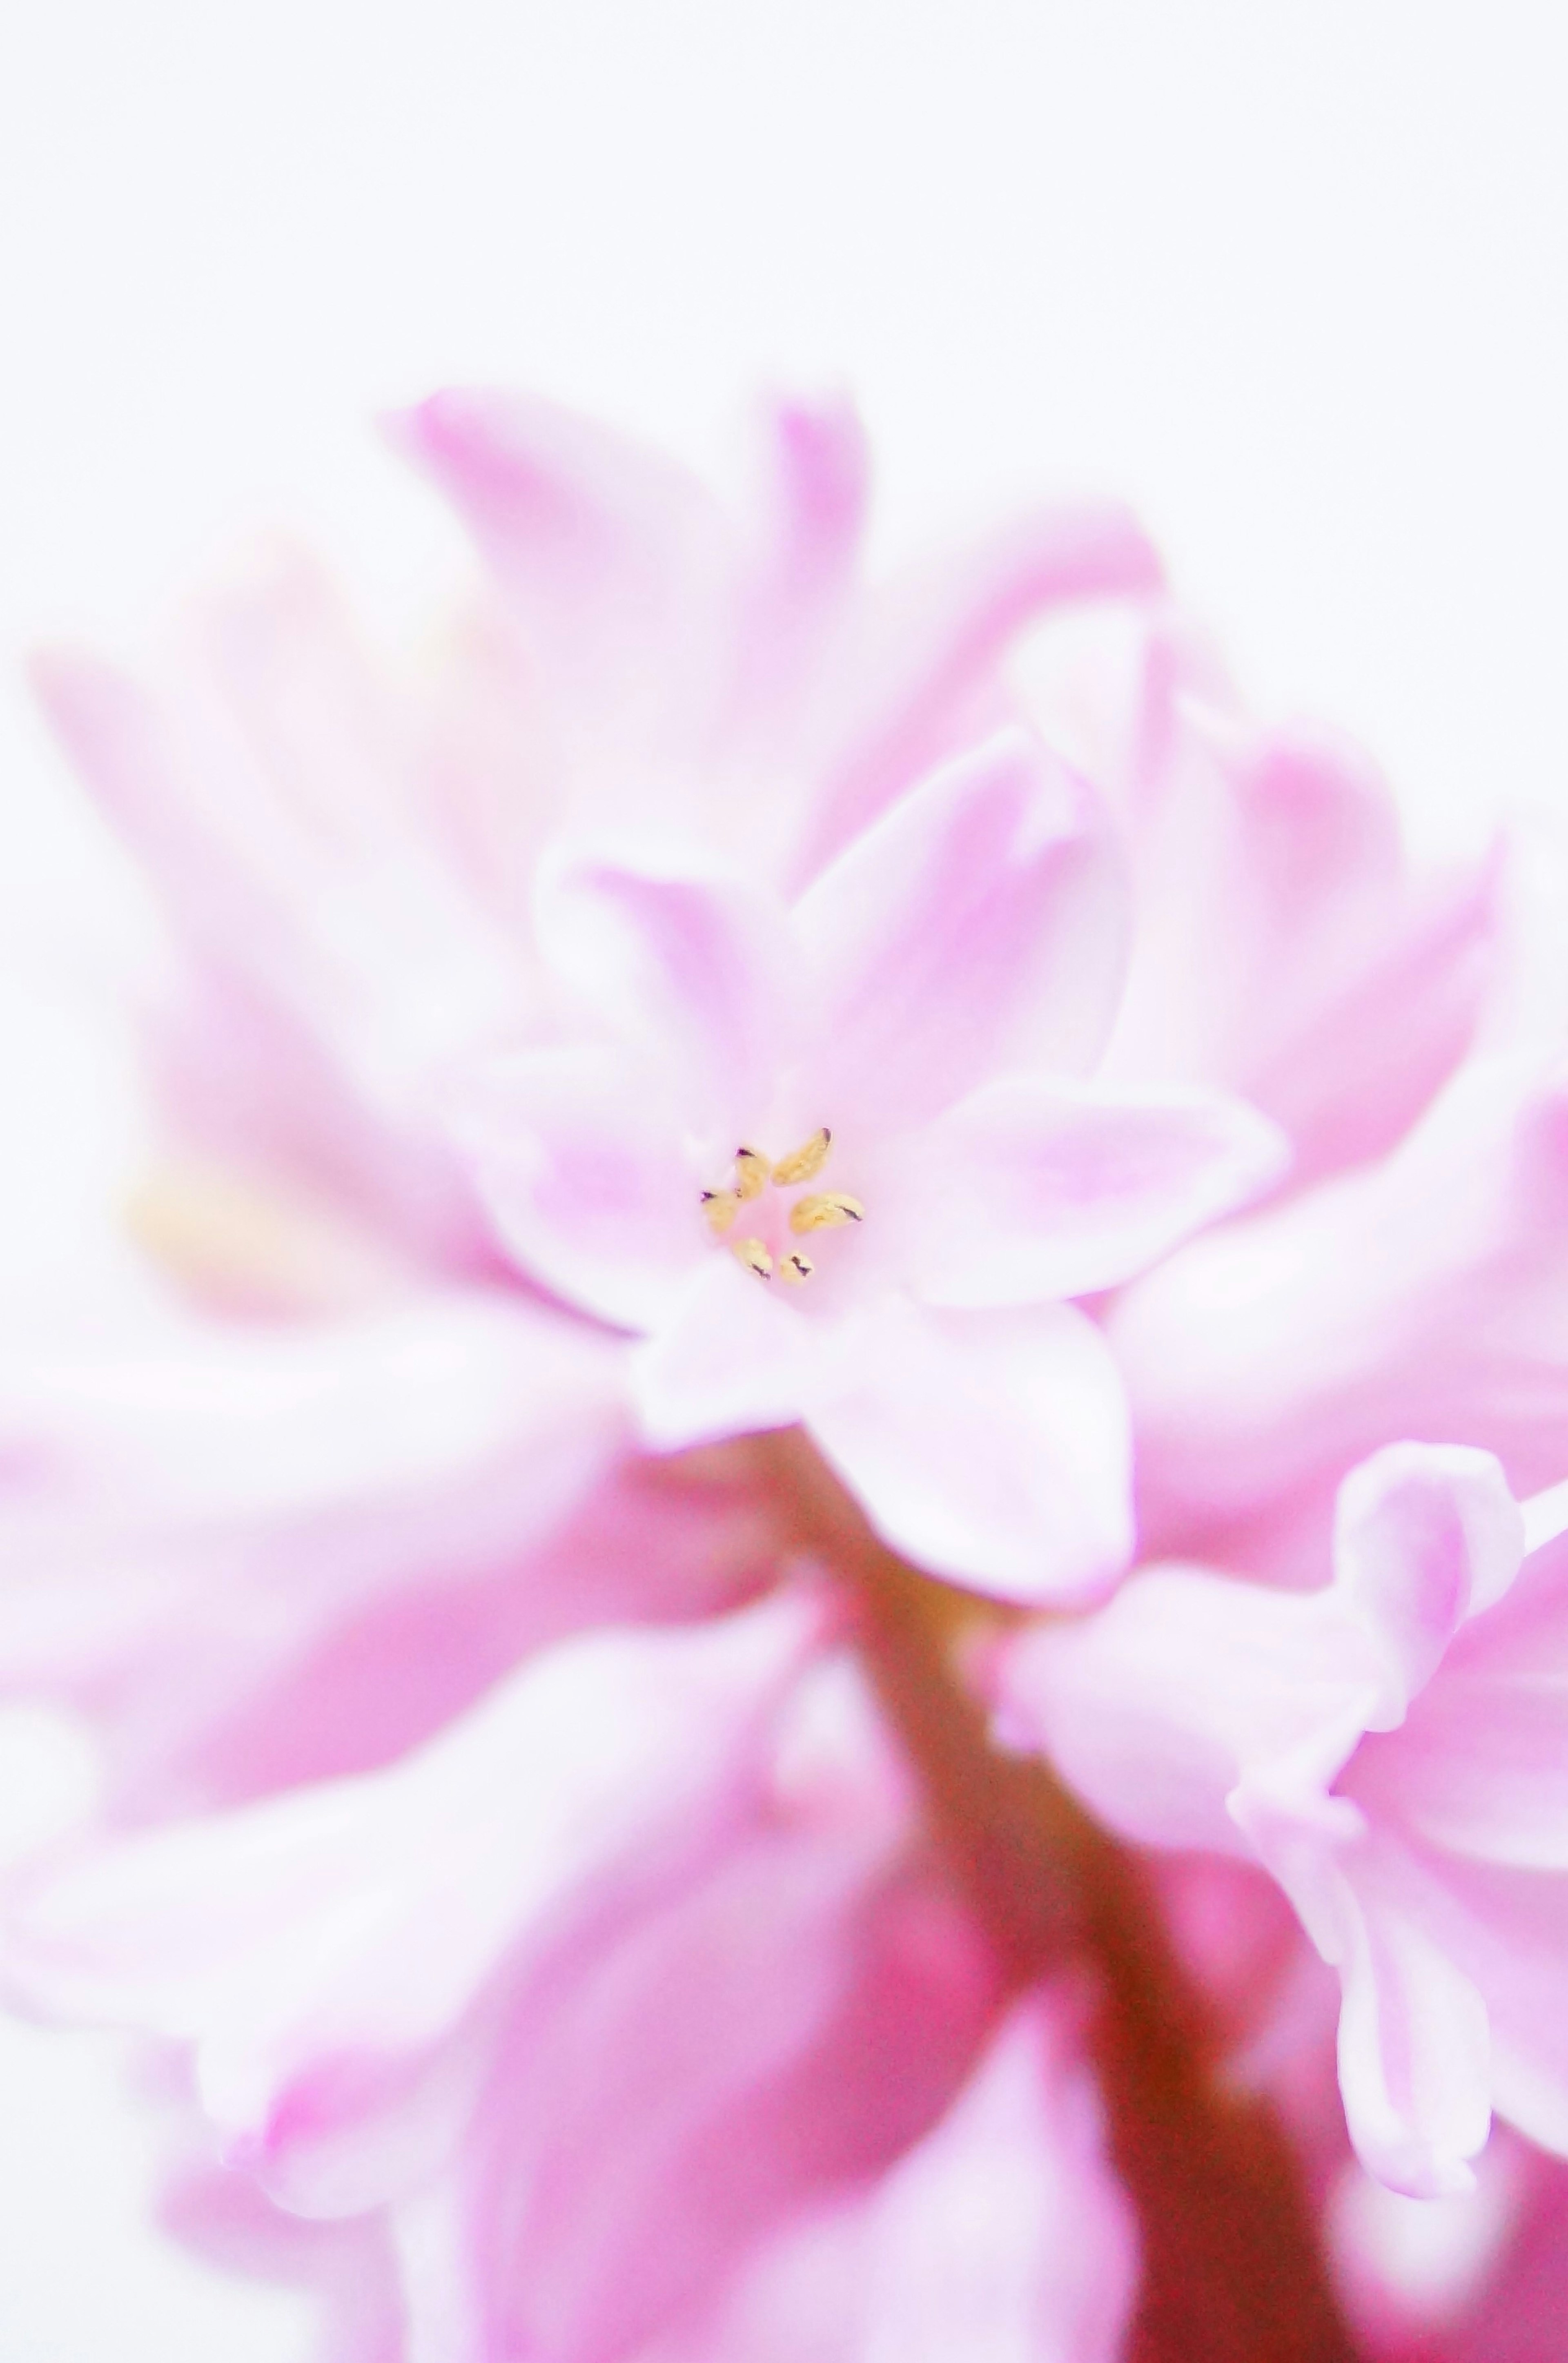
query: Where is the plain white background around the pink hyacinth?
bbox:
[0,0,1568,2363]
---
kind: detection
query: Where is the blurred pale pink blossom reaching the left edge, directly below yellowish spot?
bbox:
[0,1288,777,1819]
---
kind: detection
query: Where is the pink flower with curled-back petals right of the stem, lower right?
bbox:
[996,1444,1568,2195]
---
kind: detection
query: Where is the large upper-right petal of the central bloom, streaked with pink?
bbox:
[796,733,1122,1132]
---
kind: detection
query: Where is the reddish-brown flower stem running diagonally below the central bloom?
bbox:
[758,1430,1358,2363]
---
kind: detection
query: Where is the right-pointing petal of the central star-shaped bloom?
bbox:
[904,1075,1290,1304]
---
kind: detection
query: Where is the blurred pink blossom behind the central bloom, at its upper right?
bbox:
[1034,607,1507,1191]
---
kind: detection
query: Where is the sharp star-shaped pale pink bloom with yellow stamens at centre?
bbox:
[463,730,1285,1600]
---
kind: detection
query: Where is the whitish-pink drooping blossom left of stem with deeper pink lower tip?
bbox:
[12,1595,822,2214]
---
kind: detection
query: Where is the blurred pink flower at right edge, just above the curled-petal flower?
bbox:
[1110,1044,1568,1572]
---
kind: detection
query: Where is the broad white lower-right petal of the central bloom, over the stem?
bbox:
[805,1297,1131,1602]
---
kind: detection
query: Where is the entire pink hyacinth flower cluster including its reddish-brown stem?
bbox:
[0,395,1568,2363]
